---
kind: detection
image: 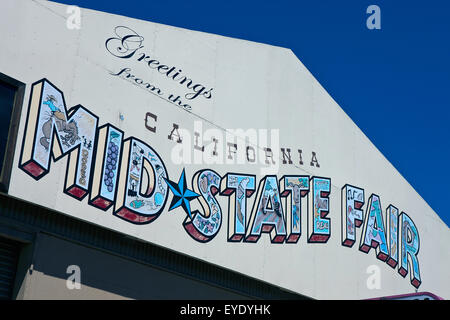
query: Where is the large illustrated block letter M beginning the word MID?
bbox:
[19,79,98,200]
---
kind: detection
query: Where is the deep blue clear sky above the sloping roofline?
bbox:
[51,0,450,226]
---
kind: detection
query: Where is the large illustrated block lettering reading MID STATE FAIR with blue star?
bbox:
[19,79,422,288]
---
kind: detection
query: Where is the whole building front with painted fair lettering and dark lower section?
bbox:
[0,0,450,299]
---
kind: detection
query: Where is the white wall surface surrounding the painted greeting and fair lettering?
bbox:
[0,0,450,299]
